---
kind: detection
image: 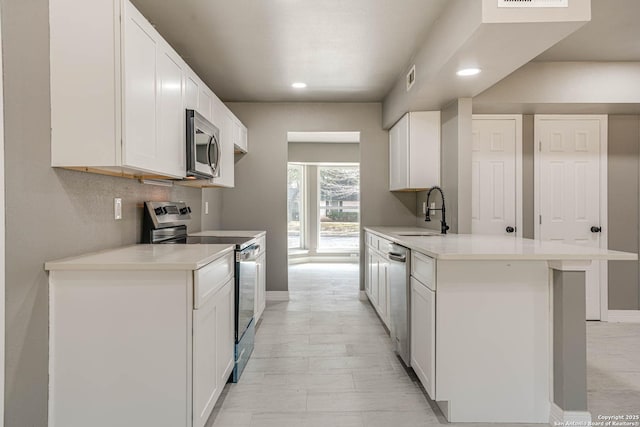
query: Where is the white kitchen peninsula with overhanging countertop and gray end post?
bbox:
[365,227,637,423]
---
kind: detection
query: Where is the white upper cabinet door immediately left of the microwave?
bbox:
[156,46,186,177]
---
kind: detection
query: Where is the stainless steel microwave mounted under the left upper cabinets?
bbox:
[186,109,220,179]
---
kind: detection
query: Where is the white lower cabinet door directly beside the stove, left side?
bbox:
[214,279,235,388]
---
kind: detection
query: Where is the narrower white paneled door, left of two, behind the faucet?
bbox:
[471,115,522,236]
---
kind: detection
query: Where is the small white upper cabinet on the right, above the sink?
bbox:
[389,111,440,191]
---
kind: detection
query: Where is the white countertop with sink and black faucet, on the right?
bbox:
[365,227,638,261]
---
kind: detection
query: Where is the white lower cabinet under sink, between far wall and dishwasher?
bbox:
[365,232,391,328]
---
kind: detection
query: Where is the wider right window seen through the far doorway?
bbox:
[318,166,360,251]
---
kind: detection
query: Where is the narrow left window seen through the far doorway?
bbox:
[287,163,304,249]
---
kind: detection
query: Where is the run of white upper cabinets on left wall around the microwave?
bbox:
[49,0,247,182]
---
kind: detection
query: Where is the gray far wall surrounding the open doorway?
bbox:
[222,103,416,291]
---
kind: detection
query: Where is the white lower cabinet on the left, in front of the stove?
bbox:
[49,253,235,427]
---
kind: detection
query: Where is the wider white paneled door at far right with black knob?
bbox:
[535,116,607,320]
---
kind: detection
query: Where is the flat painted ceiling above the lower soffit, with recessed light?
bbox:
[132,0,640,102]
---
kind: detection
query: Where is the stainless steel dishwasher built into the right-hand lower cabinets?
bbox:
[387,243,411,366]
